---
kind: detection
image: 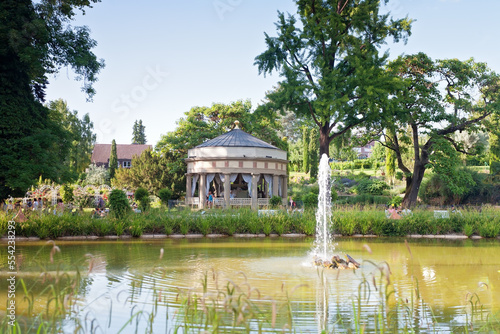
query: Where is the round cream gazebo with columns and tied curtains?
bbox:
[185,121,288,209]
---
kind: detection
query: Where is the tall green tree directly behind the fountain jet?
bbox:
[254,0,411,155]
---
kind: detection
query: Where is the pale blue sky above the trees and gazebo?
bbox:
[42,0,500,146]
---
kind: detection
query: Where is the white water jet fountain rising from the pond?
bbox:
[313,154,359,269]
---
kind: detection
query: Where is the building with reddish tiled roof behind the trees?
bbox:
[91,144,152,168]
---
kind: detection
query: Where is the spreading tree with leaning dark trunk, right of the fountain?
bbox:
[379,53,500,207]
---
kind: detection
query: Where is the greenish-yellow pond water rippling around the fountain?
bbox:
[0,237,500,333]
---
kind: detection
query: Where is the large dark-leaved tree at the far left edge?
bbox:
[0,0,104,199]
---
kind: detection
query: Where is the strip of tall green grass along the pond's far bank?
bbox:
[0,204,500,239]
